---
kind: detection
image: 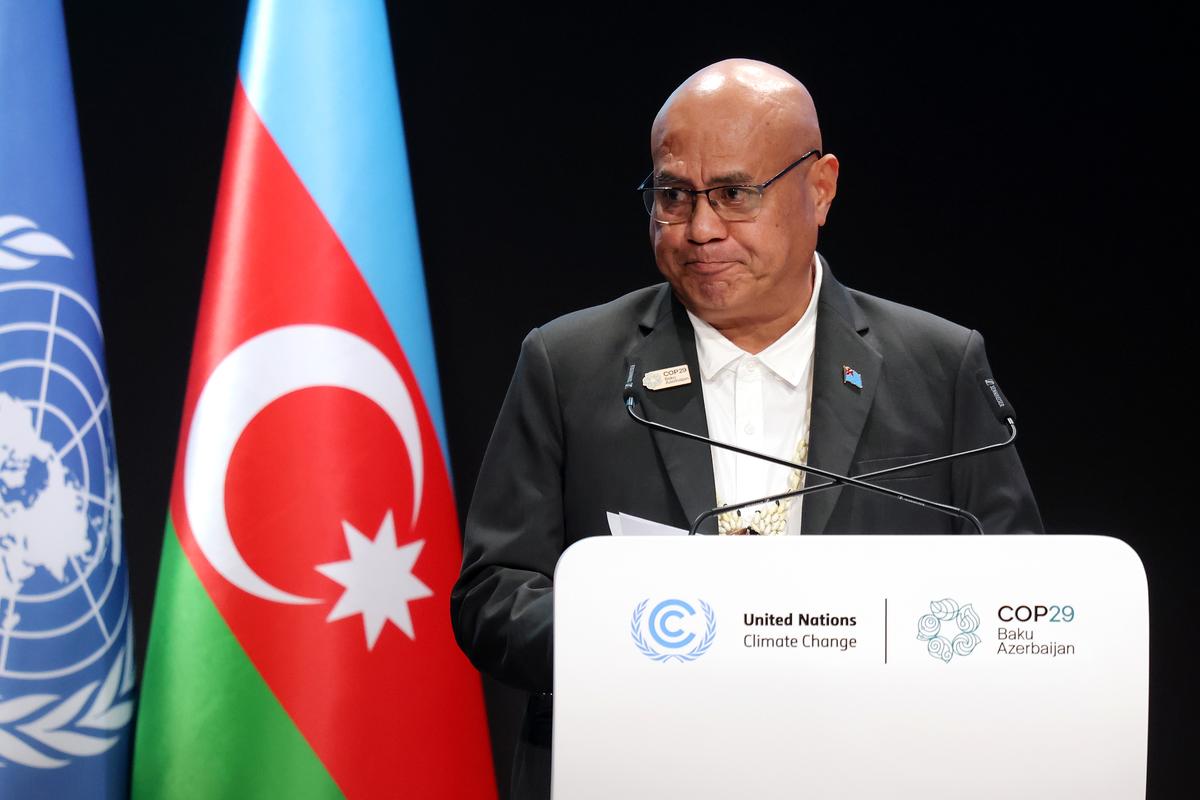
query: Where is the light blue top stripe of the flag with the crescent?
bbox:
[239,0,449,462]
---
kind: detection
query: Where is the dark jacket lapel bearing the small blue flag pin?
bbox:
[800,265,883,534]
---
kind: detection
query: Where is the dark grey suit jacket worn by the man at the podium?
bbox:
[450,269,1042,799]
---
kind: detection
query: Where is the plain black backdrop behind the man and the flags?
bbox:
[66,0,1198,796]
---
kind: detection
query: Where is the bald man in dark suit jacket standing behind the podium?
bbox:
[451,60,1042,799]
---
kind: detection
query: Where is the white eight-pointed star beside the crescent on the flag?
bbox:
[316,511,433,650]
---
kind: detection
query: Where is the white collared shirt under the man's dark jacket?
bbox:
[688,255,821,534]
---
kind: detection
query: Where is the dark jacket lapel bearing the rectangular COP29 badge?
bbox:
[625,291,716,533]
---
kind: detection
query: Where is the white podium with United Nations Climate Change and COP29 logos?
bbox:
[552,536,1150,800]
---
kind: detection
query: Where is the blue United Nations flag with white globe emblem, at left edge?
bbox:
[0,0,134,799]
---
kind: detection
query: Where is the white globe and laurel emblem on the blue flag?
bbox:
[0,279,133,768]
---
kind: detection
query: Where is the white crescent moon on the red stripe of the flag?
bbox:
[184,325,425,603]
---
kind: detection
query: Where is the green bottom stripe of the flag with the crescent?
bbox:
[133,516,342,800]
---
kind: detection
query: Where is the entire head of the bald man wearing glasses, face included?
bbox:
[650,59,838,353]
